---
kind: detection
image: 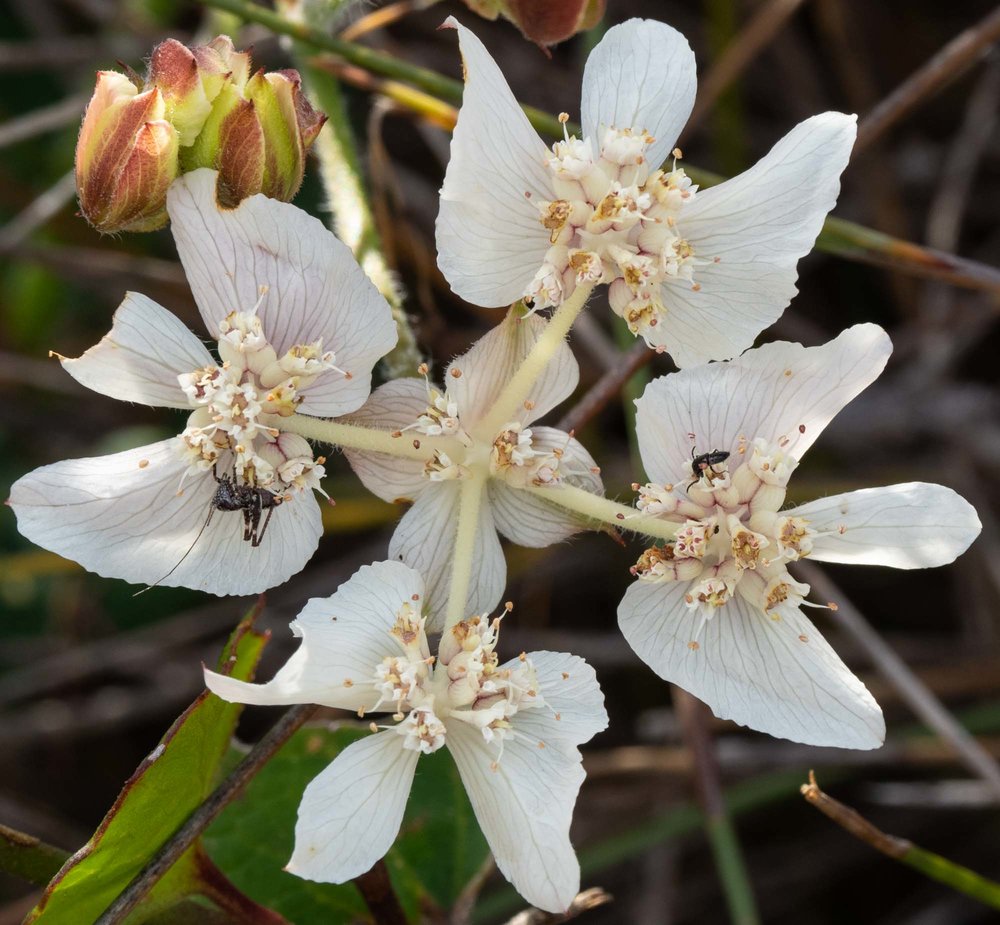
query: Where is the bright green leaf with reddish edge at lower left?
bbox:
[25,605,267,925]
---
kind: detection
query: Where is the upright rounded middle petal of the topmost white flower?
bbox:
[580,19,697,170]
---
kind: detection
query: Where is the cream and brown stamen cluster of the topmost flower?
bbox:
[524,120,708,339]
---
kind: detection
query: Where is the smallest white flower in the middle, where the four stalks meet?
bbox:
[344,312,604,628]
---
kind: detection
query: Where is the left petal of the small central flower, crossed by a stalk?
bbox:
[344,379,428,504]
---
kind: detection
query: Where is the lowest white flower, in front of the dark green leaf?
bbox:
[205,562,608,912]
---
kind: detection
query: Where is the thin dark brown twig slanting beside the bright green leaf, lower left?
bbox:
[94,703,316,925]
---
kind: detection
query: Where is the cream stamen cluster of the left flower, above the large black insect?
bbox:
[177,308,340,496]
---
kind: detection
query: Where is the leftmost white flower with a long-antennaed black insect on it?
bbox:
[10,170,396,594]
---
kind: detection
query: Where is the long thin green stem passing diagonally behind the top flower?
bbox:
[202,0,1000,291]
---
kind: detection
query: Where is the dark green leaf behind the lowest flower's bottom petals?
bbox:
[205,725,489,925]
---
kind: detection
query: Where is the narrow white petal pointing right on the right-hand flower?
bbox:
[785,482,982,568]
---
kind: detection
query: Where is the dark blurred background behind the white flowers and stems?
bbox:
[0,0,1000,925]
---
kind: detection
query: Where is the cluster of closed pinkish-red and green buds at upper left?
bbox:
[76,35,326,232]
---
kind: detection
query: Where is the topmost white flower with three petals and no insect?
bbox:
[437,18,855,367]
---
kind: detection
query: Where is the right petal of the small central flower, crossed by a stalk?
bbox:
[489,427,604,549]
